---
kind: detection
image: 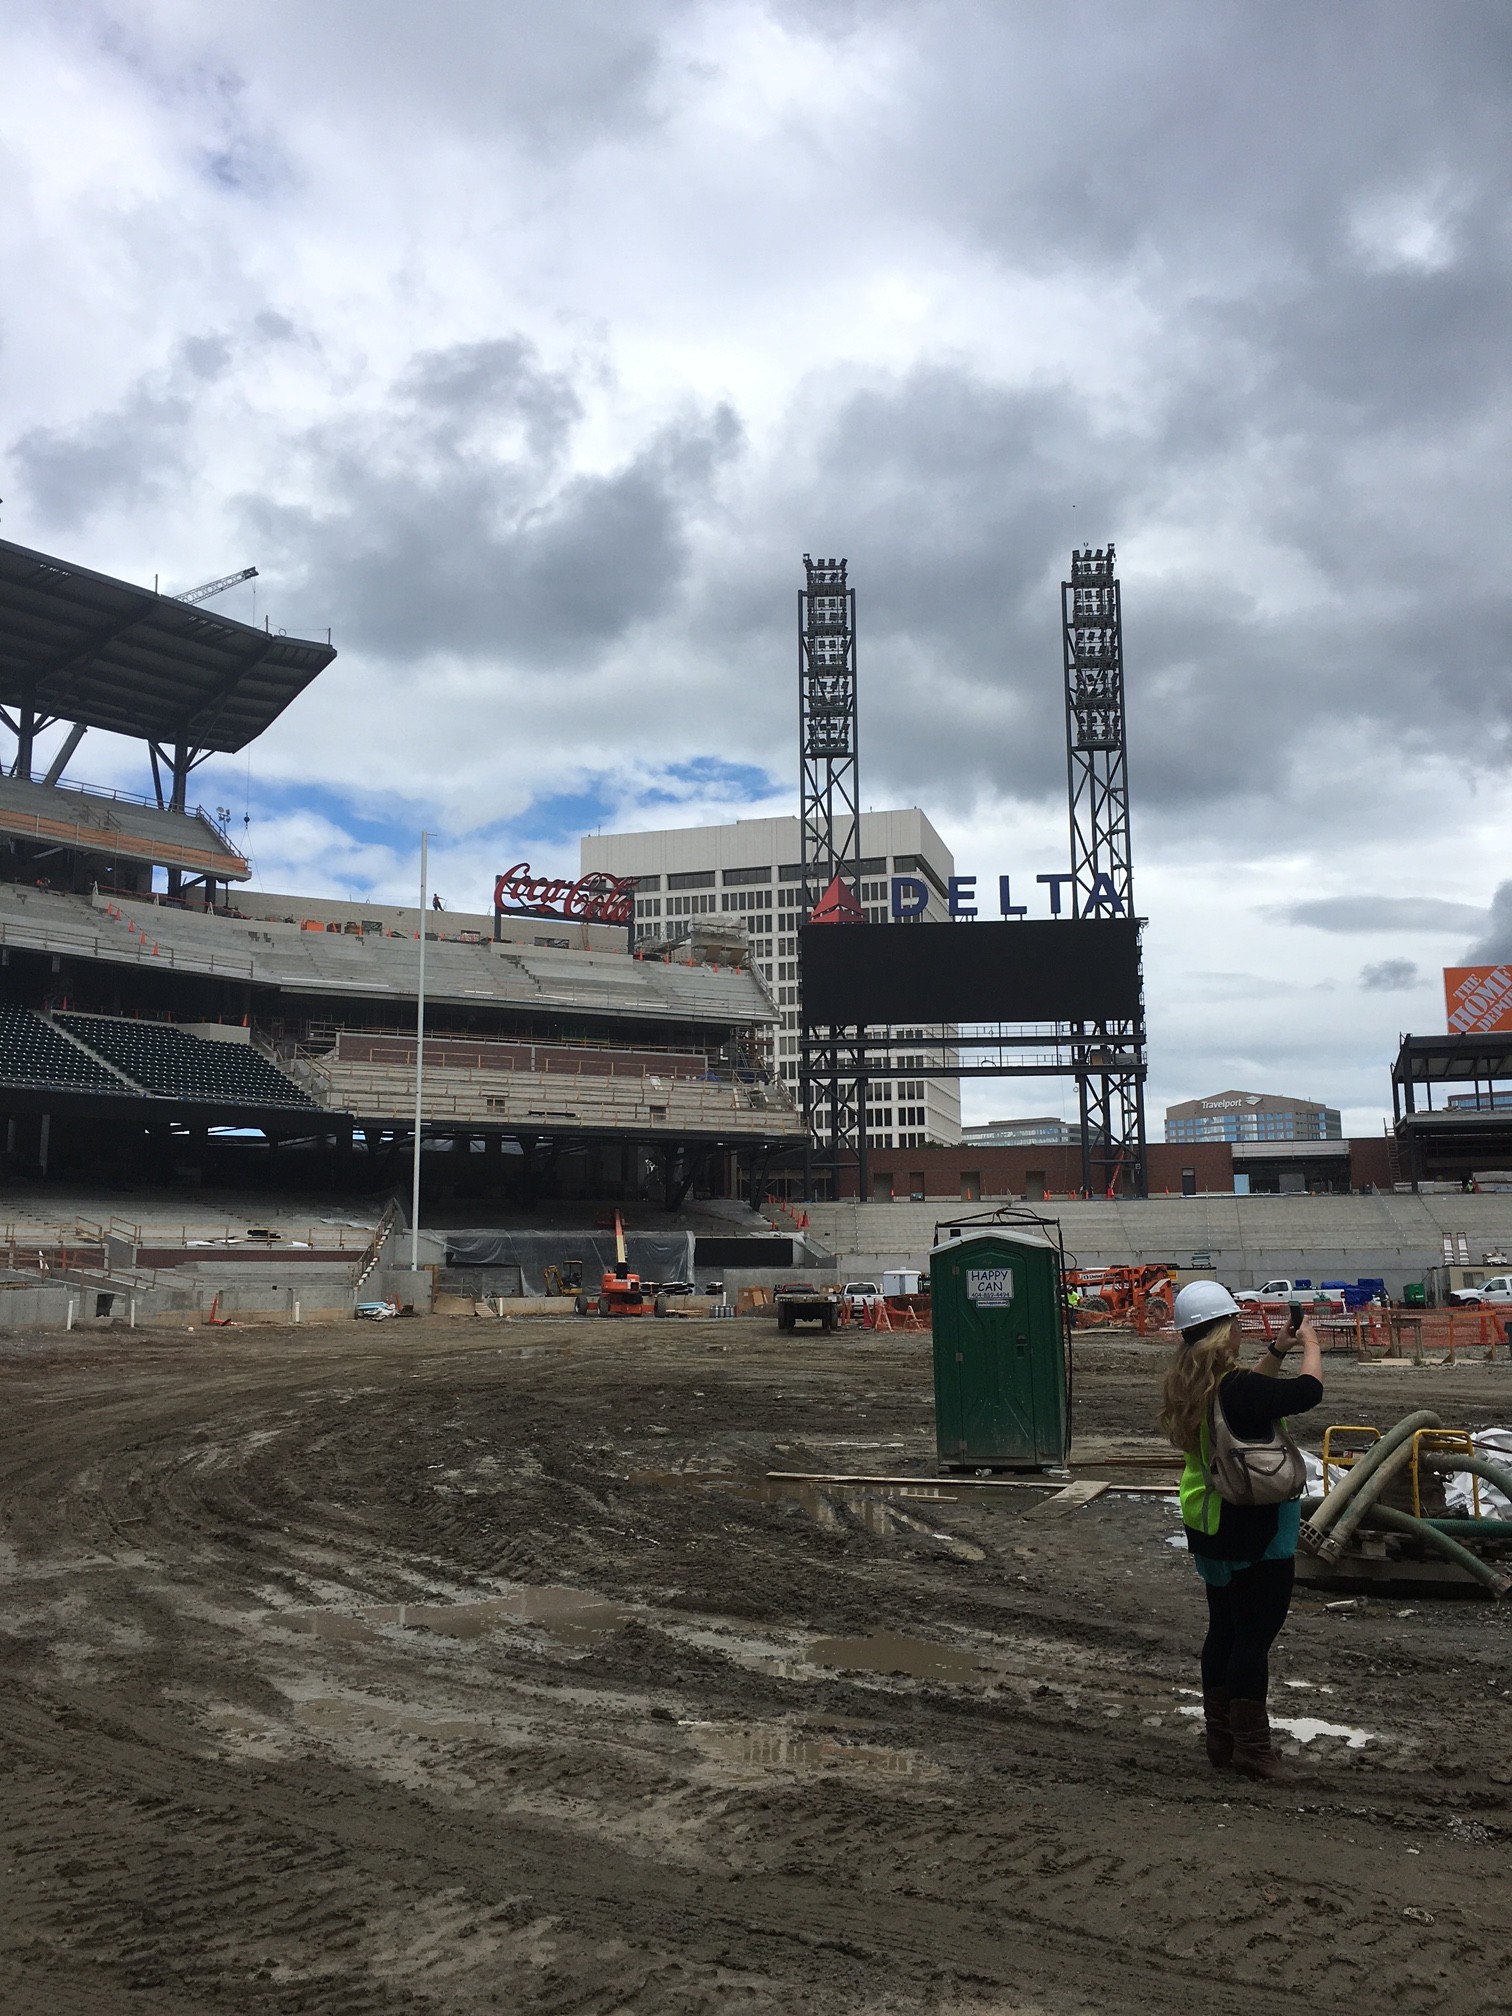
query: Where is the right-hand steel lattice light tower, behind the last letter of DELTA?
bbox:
[1060,546,1147,1198]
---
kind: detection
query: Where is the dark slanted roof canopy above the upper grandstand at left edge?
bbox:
[0,540,337,754]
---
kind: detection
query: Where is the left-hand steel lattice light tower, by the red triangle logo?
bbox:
[794,552,867,1191]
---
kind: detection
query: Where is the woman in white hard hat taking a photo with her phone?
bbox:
[1161,1280,1322,1778]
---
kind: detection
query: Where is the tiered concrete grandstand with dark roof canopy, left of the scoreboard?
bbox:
[0,542,802,1204]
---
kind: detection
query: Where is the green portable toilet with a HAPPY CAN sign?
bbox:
[929,1224,1070,1470]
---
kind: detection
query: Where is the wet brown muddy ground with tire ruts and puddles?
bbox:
[0,1322,1512,2016]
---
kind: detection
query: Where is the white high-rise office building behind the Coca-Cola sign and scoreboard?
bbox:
[581,806,962,1147]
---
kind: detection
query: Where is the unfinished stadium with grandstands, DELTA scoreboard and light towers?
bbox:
[0,542,1512,1233]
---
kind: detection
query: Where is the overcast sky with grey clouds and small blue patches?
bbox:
[0,0,1512,1133]
